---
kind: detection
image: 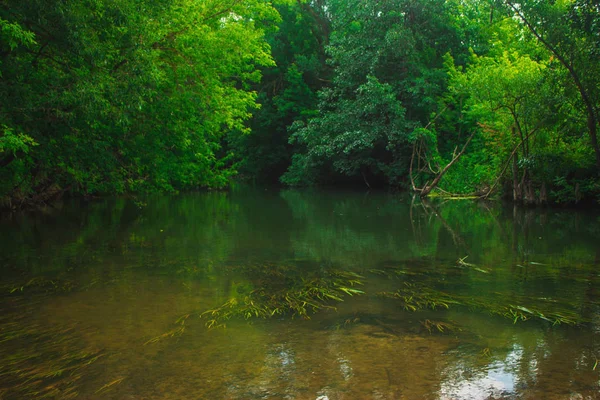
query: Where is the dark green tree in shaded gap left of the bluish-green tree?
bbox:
[228,2,329,182]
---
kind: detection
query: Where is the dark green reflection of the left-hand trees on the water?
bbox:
[0,192,244,290]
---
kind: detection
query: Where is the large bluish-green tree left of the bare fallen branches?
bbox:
[282,0,460,185]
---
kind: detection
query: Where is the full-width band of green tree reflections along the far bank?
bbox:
[0,190,600,295]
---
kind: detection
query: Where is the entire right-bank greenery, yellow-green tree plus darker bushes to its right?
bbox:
[446,16,593,203]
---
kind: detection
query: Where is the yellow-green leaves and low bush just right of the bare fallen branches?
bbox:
[446,51,546,197]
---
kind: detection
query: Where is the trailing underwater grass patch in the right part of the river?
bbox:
[369,256,591,325]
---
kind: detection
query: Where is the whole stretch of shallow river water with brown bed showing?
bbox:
[0,188,600,400]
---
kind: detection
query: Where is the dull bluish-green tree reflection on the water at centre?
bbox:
[281,190,439,266]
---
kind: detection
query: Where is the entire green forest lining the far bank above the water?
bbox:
[0,0,600,208]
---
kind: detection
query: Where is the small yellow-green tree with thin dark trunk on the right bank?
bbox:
[450,51,545,201]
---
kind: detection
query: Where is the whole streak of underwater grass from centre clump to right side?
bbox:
[145,257,584,345]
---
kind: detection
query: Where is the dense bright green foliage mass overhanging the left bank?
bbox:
[0,0,279,200]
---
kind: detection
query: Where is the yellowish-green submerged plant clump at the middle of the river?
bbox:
[201,270,364,328]
